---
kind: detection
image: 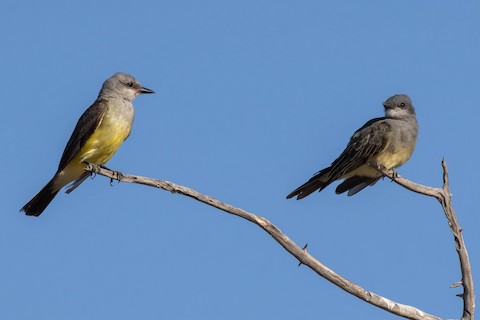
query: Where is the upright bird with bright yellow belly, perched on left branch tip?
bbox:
[20,72,155,217]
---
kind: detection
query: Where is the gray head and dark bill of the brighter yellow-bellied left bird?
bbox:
[98,72,155,102]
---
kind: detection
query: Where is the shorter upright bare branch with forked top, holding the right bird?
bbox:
[377,159,475,320]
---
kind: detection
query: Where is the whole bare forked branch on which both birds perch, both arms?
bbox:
[86,164,475,320]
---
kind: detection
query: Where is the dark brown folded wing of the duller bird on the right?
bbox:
[327,118,392,184]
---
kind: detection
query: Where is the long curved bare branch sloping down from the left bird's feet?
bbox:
[86,164,456,320]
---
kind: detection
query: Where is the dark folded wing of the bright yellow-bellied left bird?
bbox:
[58,99,108,171]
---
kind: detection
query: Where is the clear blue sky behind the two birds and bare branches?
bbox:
[0,0,480,320]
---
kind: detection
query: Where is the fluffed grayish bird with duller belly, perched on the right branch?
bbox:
[287,94,418,200]
